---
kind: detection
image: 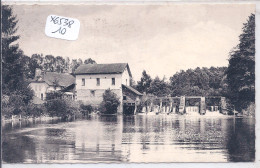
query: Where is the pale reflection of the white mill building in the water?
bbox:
[75,116,122,162]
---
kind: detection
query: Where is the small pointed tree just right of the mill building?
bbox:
[136,70,152,93]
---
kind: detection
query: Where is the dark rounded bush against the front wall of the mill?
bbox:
[100,89,120,114]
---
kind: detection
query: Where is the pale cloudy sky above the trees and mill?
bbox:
[13,4,255,81]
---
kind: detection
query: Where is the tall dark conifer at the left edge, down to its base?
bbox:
[2,5,33,107]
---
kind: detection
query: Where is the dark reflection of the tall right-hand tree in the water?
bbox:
[227,118,255,162]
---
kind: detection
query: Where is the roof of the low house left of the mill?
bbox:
[32,72,75,87]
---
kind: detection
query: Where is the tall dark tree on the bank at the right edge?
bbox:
[226,14,255,111]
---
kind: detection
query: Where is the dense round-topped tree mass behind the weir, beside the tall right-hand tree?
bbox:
[170,67,226,96]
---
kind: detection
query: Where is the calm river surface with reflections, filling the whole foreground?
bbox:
[3,115,255,163]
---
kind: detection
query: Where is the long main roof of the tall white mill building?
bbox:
[74,63,132,76]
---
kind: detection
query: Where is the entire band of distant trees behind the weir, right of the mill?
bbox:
[135,67,227,97]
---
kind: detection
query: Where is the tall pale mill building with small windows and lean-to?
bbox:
[74,63,142,113]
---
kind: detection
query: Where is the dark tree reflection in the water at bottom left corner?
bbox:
[2,134,36,163]
